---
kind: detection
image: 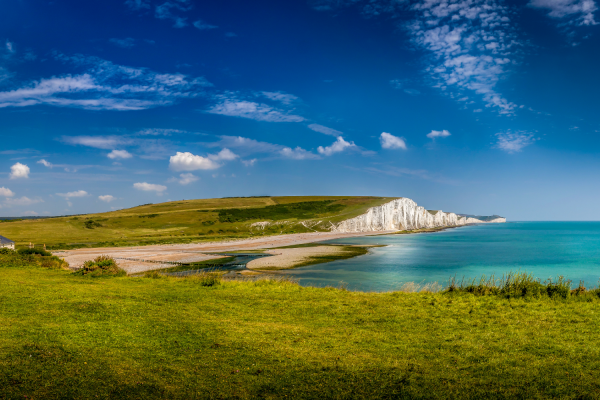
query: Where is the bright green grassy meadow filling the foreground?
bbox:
[0,266,600,399]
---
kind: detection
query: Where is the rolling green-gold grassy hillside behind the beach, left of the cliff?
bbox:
[0,196,393,249]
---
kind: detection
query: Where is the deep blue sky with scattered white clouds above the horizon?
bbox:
[0,0,600,220]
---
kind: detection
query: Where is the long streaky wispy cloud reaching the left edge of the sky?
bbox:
[0,54,212,111]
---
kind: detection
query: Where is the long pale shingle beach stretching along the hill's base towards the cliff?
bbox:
[53,231,392,274]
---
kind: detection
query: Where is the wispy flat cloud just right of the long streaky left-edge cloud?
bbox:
[206,99,304,122]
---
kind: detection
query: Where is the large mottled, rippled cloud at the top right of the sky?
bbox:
[407,0,519,114]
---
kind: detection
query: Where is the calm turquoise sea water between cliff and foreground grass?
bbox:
[288,222,600,291]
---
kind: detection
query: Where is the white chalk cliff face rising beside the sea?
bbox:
[331,198,506,232]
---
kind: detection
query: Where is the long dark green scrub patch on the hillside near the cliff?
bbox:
[219,200,345,222]
